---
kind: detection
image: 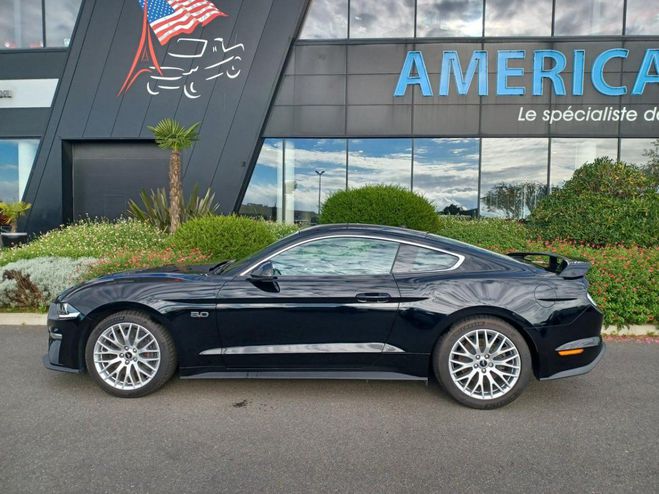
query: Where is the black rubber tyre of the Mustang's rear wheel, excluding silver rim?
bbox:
[433,316,533,409]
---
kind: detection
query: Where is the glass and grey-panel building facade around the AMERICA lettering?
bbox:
[240,0,659,224]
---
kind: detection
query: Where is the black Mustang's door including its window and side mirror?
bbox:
[218,236,400,369]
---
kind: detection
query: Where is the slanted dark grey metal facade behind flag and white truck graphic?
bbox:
[20,0,310,232]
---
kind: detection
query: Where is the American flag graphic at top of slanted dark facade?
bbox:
[138,0,226,45]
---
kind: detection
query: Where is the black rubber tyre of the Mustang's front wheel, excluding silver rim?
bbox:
[85,311,177,398]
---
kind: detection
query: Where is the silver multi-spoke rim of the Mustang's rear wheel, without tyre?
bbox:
[448,329,522,400]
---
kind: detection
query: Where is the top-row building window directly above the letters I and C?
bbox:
[554,0,628,36]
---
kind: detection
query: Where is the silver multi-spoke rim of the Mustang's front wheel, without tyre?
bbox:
[94,322,161,391]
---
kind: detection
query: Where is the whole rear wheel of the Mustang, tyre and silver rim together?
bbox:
[433,316,532,409]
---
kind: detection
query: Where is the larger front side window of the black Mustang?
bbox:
[271,237,398,276]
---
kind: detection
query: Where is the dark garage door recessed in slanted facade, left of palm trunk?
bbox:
[72,142,169,219]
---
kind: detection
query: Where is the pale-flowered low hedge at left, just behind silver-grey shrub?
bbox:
[0,220,167,266]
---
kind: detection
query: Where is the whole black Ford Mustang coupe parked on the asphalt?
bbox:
[44,225,605,408]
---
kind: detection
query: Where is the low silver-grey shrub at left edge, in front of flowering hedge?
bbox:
[0,257,96,308]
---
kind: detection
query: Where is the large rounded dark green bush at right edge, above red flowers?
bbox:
[529,158,659,247]
